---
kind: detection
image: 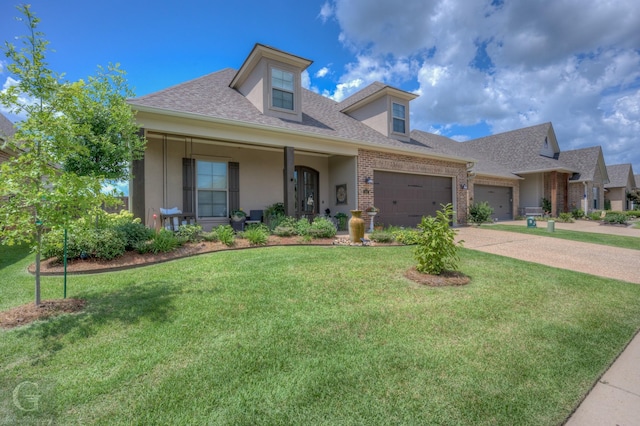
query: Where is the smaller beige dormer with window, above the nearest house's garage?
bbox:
[340,82,418,142]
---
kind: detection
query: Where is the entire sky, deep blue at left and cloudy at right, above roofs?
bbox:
[0,0,640,174]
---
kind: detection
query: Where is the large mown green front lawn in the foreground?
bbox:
[0,246,640,425]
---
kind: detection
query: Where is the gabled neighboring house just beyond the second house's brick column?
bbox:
[559,146,609,214]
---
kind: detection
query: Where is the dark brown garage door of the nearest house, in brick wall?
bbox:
[373,171,452,227]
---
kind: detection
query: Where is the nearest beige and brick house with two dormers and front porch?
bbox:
[129,44,474,229]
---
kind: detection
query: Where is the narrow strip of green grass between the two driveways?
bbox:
[486,222,640,250]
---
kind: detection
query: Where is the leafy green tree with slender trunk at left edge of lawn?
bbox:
[0,5,144,305]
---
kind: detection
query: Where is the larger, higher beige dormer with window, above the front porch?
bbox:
[229,43,312,121]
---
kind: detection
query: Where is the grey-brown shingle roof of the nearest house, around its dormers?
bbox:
[128,68,466,161]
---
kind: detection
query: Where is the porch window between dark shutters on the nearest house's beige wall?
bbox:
[196,160,228,217]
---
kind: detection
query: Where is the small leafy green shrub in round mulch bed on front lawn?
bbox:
[414,203,462,275]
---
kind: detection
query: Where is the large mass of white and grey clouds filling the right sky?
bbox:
[325,0,640,173]
